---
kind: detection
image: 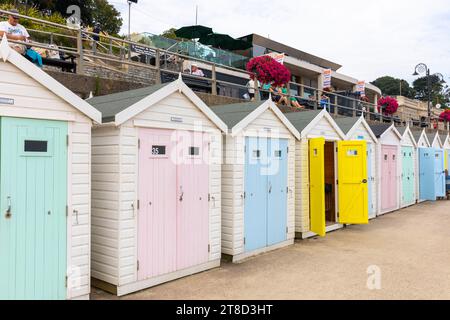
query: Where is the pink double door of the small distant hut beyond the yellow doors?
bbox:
[381,145,398,212]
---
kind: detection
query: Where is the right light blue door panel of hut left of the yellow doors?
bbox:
[267,139,289,246]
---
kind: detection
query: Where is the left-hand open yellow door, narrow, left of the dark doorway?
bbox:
[309,138,326,237]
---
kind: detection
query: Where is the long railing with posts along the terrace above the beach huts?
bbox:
[0,9,444,131]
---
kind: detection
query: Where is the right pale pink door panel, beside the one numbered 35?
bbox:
[177,131,209,270]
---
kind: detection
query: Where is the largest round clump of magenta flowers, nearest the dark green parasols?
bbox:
[247,56,291,86]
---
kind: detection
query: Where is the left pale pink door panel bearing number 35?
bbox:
[138,129,177,280]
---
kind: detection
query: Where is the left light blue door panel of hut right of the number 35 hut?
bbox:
[244,137,268,252]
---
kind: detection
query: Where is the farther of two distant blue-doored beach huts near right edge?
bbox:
[427,131,446,198]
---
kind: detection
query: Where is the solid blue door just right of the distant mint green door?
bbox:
[419,148,436,201]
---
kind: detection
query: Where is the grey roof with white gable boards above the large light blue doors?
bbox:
[211,99,300,139]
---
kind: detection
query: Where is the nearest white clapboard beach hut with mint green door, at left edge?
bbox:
[0,37,101,300]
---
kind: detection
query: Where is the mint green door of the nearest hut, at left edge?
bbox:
[0,117,67,300]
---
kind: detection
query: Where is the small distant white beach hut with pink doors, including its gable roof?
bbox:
[370,124,402,215]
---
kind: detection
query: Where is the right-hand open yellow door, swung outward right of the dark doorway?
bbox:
[338,141,369,224]
